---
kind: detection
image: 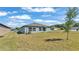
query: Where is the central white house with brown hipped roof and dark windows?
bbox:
[19,23,51,33]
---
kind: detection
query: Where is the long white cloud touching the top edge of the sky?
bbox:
[22,7,56,12]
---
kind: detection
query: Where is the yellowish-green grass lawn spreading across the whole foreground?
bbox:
[0,31,79,51]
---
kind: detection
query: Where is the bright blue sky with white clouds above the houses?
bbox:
[0,7,79,28]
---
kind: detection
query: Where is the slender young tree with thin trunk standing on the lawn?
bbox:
[65,7,78,40]
